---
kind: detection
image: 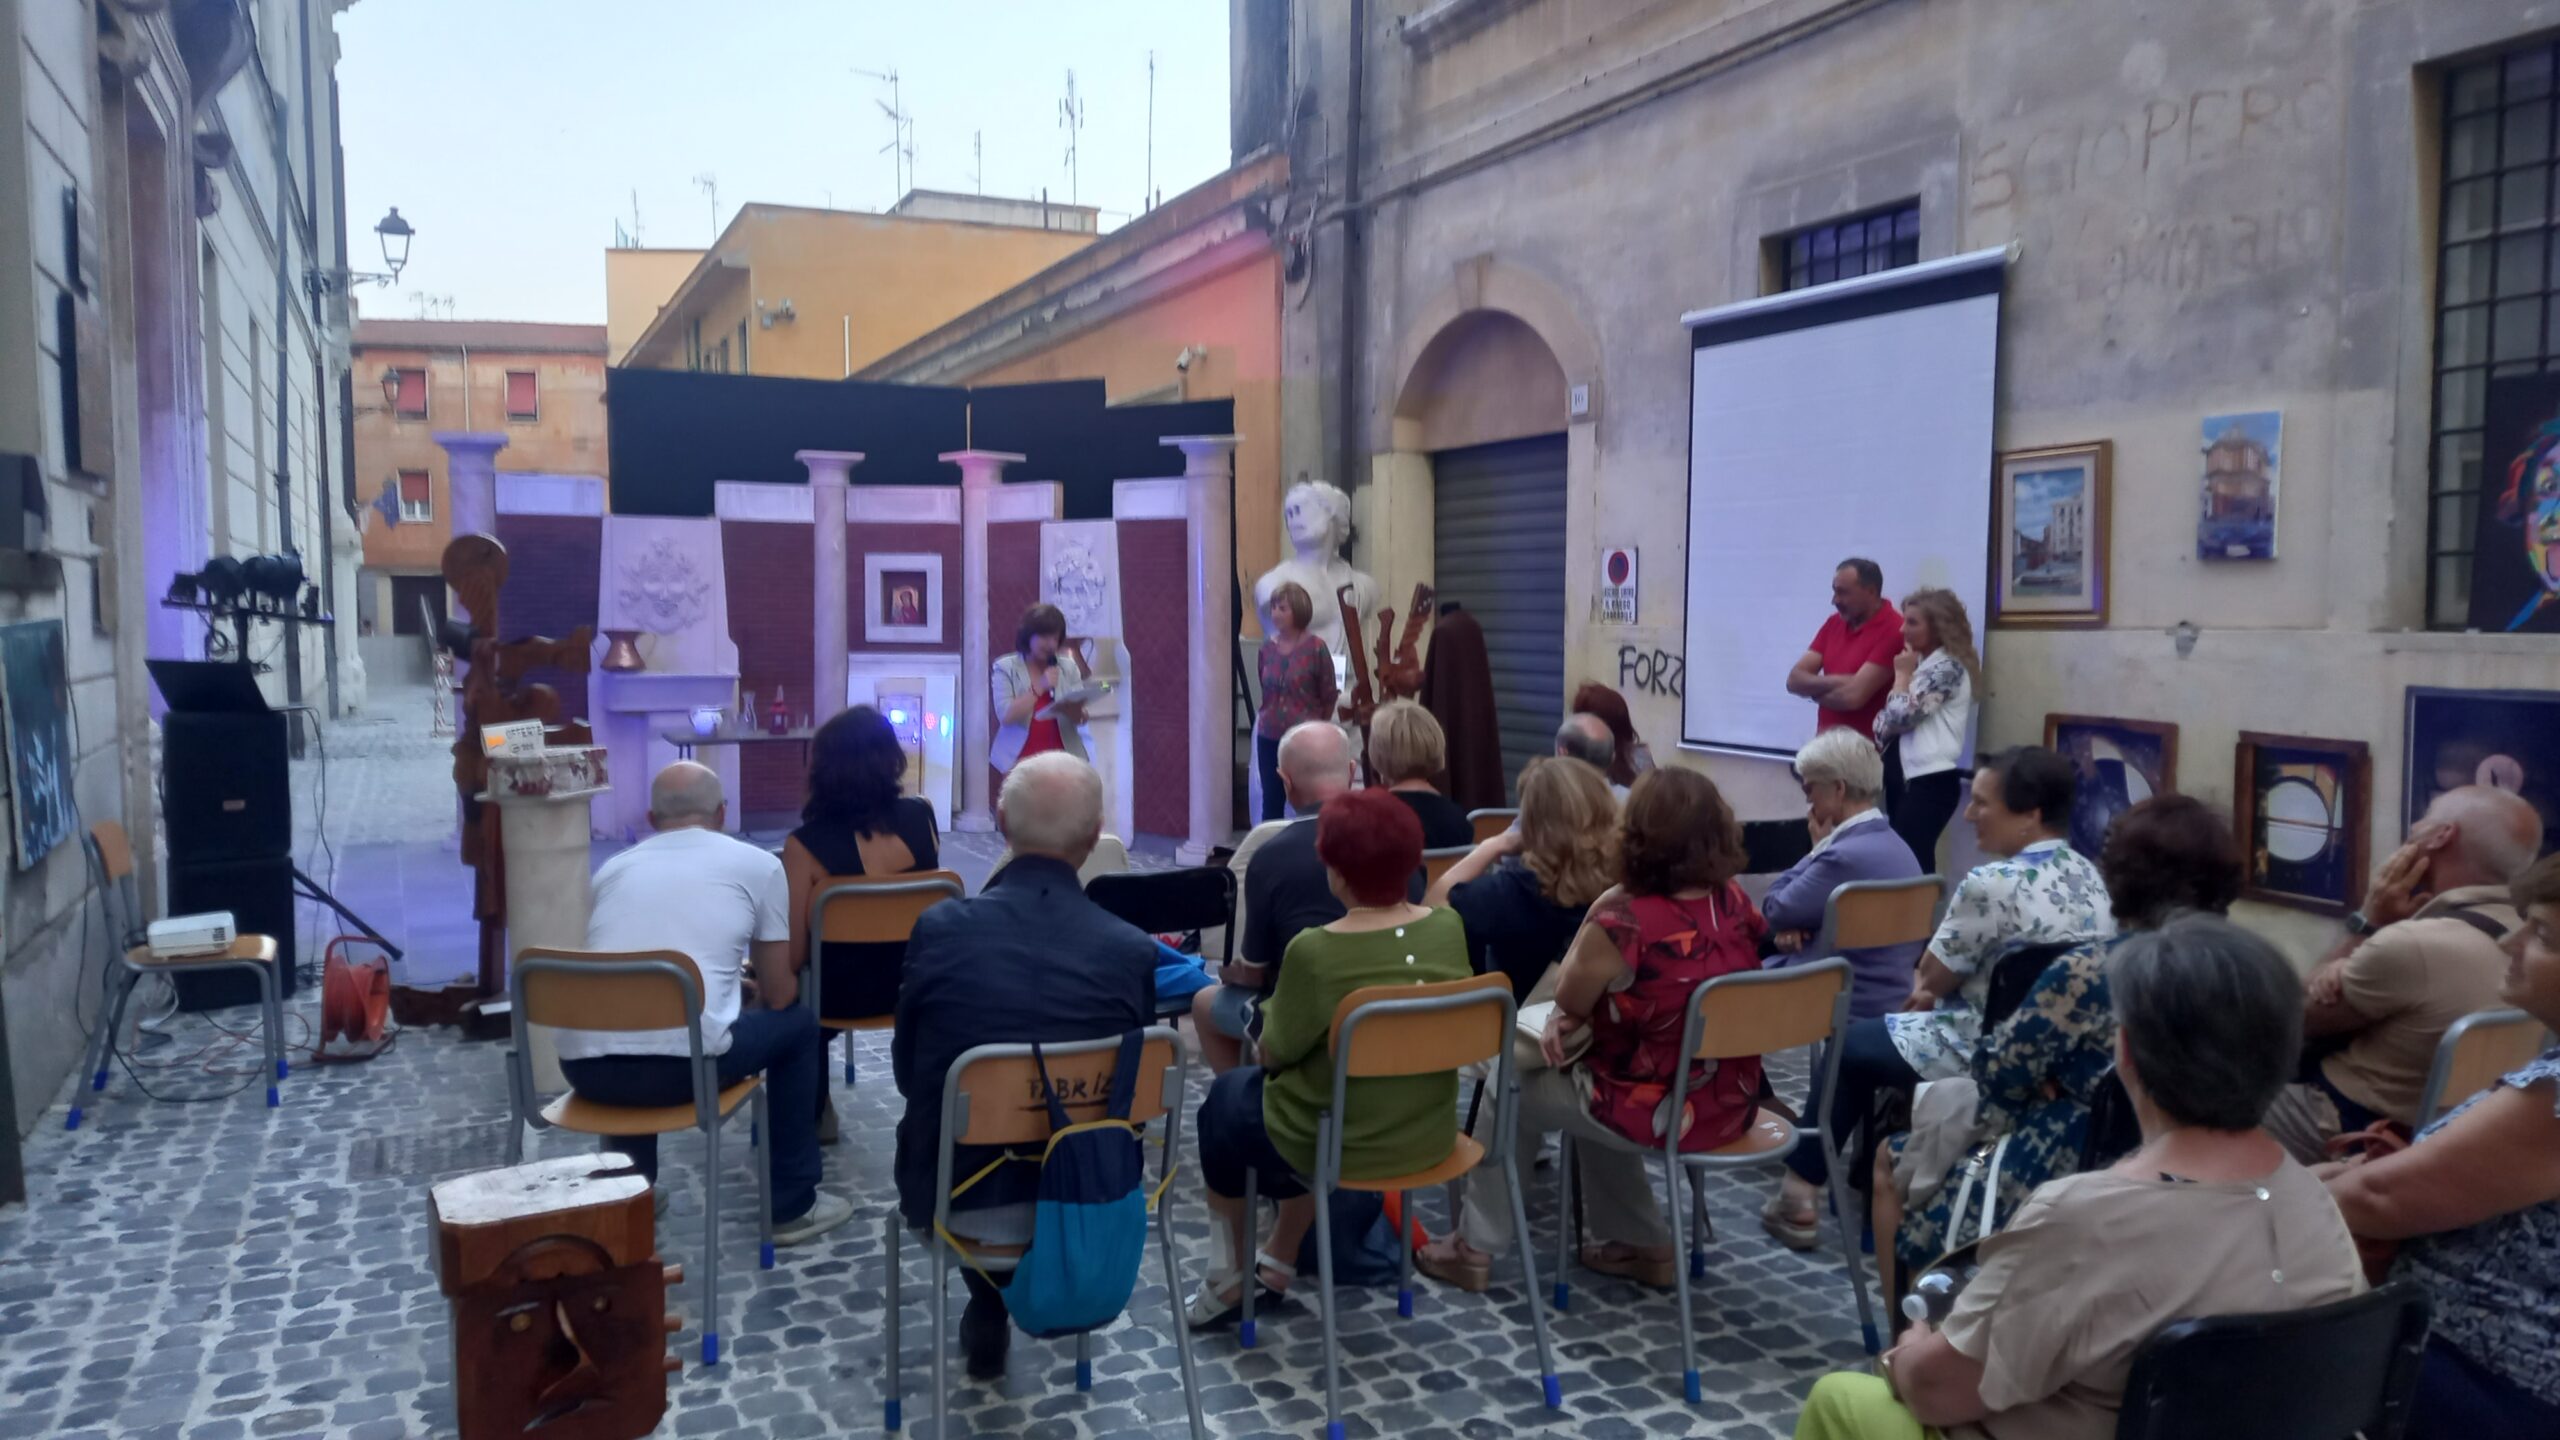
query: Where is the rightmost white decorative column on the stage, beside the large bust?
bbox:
[1165,436,1236,866]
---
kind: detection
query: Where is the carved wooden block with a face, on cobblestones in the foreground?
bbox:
[428,1156,684,1440]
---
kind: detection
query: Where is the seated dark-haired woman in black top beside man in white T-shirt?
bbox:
[783,705,942,1020]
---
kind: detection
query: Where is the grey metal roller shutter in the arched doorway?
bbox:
[1433,436,1564,797]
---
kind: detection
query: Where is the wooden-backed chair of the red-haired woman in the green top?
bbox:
[1236,974,1564,1440]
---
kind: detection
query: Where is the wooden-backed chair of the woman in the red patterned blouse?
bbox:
[1523,958,1882,1404]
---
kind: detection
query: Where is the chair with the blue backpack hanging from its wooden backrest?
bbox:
[881,1025,1206,1437]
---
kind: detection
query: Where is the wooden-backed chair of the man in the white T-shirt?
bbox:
[507,945,773,1366]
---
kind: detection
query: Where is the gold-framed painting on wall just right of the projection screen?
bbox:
[1992,441,2115,628]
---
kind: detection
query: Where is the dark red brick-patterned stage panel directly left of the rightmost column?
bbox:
[1119,520,1190,835]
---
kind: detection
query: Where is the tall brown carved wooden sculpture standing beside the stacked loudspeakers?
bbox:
[443,536,596,999]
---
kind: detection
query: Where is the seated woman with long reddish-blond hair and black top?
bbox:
[1423,756,1618,1004]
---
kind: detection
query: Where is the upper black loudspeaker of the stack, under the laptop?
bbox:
[161,710,294,855]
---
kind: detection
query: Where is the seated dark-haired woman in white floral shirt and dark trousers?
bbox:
[1787,746,2115,1209]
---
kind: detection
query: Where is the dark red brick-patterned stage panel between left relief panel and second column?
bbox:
[719,520,808,815]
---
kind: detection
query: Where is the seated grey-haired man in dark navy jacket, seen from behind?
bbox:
[888,751,1157,1381]
